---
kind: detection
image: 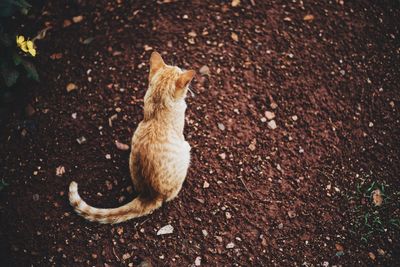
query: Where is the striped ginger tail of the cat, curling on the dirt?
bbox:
[69,182,163,224]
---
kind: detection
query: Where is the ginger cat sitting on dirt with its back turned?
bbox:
[69,52,195,224]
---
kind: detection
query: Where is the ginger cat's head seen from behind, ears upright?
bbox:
[144,52,196,108]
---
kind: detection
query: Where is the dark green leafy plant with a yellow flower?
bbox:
[0,0,39,90]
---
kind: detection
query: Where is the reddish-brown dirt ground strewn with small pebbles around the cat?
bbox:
[0,0,400,266]
